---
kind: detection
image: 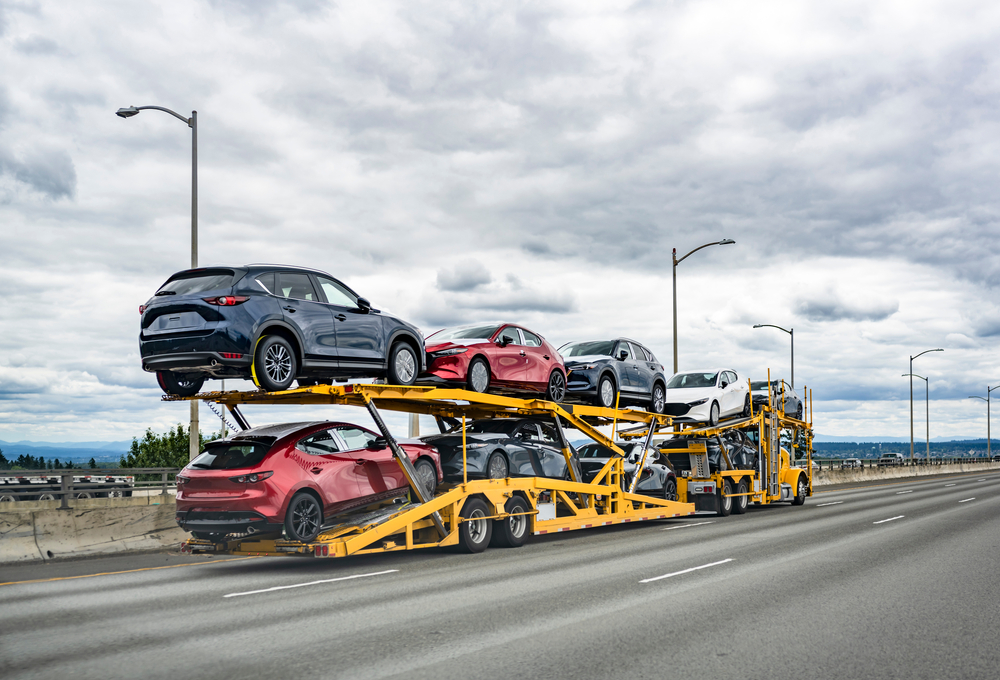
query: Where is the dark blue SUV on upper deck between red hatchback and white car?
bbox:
[559,338,667,413]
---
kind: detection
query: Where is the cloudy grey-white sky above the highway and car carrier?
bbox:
[0,0,1000,441]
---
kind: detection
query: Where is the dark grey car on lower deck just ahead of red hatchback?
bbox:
[421,418,568,482]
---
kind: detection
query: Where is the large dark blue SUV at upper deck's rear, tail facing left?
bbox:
[139,264,425,396]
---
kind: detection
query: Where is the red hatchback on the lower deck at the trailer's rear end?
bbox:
[177,422,442,541]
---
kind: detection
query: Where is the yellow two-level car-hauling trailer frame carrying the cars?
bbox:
[164,384,694,557]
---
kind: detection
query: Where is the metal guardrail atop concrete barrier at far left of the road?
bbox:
[0,468,180,509]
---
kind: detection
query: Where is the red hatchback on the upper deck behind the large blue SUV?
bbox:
[421,323,566,402]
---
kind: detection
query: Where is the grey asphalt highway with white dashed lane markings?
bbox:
[0,472,1000,680]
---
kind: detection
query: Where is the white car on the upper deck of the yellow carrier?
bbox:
[663,368,750,425]
